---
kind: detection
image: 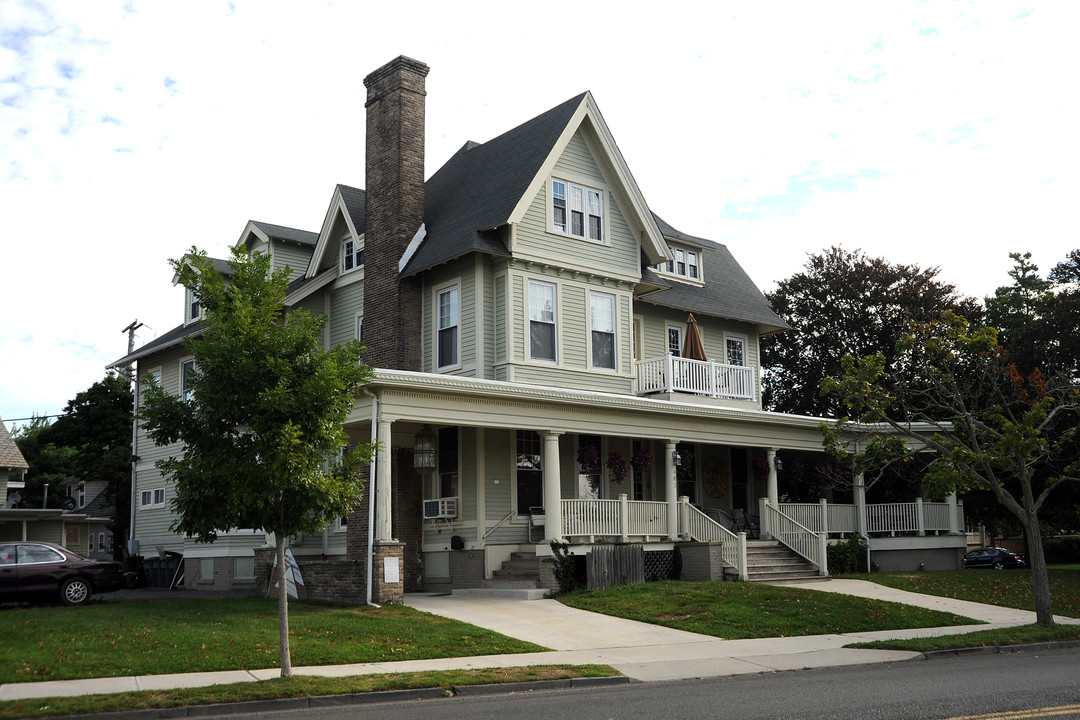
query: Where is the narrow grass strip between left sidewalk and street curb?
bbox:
[0,665,619,720]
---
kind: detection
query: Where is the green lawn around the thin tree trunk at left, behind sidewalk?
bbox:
[0,597,545,682]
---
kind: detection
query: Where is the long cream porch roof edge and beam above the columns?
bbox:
[349,369,821,450]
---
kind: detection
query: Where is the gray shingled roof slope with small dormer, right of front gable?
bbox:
[640,214,791,332]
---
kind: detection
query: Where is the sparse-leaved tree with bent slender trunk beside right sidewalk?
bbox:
[823,313,1080,624]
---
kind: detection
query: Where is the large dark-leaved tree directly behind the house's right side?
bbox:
[761,247,980,417]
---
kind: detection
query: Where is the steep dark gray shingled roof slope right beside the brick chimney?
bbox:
[402,93,585,275]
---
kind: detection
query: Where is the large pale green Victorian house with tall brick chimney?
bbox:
[113,57,963,601]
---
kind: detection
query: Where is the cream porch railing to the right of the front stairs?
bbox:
[779,498,964,535]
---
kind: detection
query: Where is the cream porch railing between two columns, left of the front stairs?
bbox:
[562,494,669,542]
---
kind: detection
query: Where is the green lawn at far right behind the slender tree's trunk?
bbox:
[845,566,1080,617]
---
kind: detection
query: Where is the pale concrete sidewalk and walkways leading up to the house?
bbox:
[0,580,1080,701]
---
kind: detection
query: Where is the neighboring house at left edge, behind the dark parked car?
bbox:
[0,420,90,555]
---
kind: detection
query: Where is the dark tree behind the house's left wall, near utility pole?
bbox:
[49,375,134,542]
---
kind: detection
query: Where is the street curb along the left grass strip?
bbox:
[46,675,630,720]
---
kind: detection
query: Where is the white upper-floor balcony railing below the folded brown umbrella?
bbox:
[637,355,757,400]
